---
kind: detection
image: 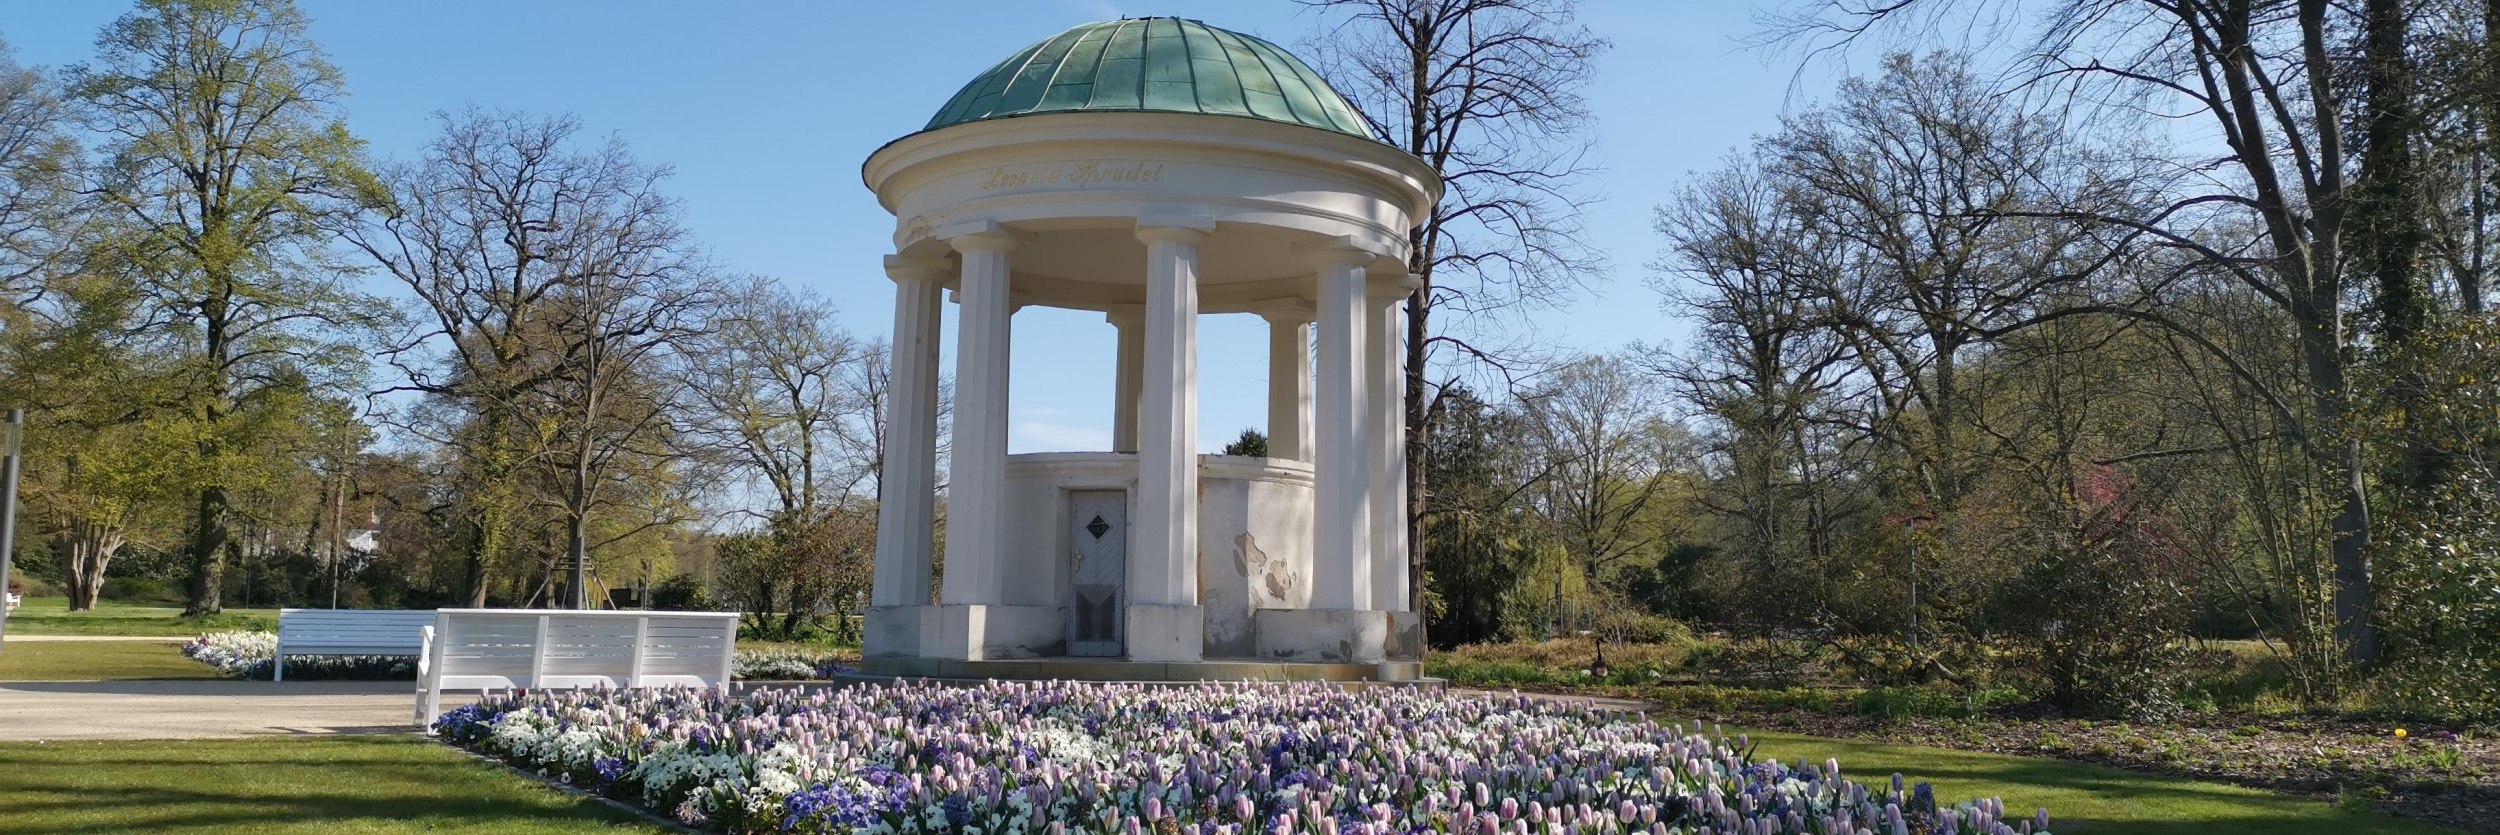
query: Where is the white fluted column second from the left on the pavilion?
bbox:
[940,230,1015,605]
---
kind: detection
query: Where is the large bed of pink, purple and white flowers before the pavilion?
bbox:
[435,683,2048,835]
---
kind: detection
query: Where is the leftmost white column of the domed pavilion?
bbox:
[870,255,945,605]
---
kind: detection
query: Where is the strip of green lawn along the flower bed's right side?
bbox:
[1730,730,2458,835]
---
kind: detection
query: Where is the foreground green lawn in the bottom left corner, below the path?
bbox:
[0,735,665,835]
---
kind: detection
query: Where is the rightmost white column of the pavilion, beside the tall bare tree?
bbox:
[1363,285,1408,613]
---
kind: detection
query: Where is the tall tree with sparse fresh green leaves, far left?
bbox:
[70,0,388,613]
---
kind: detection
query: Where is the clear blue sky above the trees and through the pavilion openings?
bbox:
[0,0,1830,453]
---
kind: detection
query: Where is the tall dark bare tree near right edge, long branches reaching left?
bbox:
[1780,0,2378,663]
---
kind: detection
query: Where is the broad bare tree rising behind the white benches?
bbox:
[340,110,683,605]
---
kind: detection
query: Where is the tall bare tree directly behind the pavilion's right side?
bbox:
[1303,0,1608,613]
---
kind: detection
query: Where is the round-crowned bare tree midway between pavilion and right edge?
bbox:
[1768,53,2095,515]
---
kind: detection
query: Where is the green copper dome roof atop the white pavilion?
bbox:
[923,18,1378,140]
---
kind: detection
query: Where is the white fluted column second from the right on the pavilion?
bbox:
[1310,248,1373,610]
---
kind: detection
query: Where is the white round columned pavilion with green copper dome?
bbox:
[863,18,1440,680]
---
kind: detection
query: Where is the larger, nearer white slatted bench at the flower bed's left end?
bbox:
[418,610,738,733]
